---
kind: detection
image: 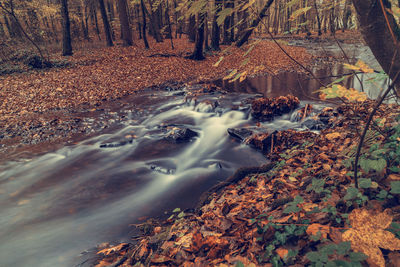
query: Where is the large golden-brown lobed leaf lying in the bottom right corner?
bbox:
[342,209,400,267]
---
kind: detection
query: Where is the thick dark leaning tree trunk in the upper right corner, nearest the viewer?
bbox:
[353,0,400,87]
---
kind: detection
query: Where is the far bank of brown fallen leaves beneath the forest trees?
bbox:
[0,39,311,159]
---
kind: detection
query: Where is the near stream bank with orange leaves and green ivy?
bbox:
[94,101,400,267]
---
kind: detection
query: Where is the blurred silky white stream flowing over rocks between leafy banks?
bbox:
[0,40,388,266]
